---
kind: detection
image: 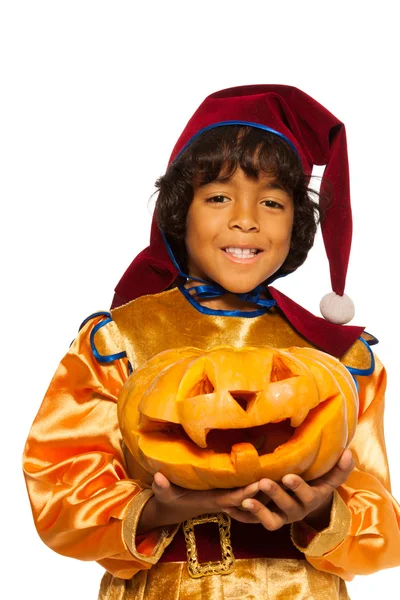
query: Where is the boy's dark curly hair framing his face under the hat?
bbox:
[155,125,320,279]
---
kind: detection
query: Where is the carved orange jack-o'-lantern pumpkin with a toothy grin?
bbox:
[118,346,358,490]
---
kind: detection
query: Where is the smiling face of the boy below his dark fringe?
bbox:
[185,169,294,293]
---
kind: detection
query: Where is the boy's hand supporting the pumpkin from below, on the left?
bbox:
[137,473,259,533]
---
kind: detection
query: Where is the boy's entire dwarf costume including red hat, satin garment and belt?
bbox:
[24,85,400,600]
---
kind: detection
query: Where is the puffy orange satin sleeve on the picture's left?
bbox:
[23,318,175,578]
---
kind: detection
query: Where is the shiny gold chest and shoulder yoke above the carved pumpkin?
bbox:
[108,288,371,369]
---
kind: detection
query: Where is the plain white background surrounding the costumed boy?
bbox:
[0,0,400,600]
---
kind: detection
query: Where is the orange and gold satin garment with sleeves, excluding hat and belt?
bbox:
[24,288,400,600]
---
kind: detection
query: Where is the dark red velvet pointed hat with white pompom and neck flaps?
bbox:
[113,85,363,356]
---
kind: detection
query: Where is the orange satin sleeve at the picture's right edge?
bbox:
[292,357,400,581]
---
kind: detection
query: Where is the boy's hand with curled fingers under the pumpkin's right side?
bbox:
[223,449,354,531]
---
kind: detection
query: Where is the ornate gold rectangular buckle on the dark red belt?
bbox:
[183,513,236,579]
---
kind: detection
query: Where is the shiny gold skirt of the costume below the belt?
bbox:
[99,558,349,600]
